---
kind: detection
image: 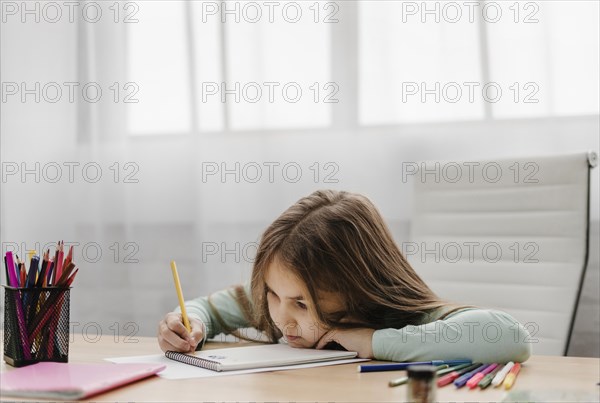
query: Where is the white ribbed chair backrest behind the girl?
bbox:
[402,152,597,355]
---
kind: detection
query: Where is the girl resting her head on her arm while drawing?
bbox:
[158,190,530,363]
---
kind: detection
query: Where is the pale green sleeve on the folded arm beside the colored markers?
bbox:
[372,309,531,363]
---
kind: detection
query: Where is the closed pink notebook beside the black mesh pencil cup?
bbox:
[0,362,165,400]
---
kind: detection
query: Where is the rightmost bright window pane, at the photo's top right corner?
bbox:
[488,1,600,118]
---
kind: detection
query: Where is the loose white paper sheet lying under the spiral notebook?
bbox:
[105,354,369,379]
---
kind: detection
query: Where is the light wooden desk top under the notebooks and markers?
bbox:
[0,335,600,402]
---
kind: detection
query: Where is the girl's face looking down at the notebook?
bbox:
[265,258,345,348]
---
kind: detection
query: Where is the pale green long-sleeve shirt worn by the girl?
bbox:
[175,283,531,363]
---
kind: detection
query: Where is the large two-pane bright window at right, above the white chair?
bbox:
[359,1,599,125]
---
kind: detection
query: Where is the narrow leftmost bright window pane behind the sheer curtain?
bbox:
[127,1,191,135]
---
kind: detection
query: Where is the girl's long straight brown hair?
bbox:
[243,190,456,342]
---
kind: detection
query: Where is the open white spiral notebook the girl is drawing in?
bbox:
[165,344,357,371]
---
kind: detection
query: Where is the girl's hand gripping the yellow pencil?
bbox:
[158,312,205,353]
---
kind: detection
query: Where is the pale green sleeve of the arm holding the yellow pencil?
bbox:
[173,282,252,340]
